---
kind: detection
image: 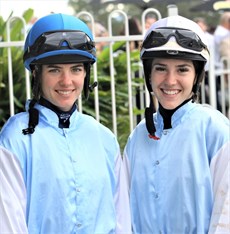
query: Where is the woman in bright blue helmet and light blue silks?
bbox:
[0,14,130,234]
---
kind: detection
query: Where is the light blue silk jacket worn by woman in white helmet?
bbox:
[124,102,230,234]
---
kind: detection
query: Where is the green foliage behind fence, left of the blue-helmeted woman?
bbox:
[0,9,33,128]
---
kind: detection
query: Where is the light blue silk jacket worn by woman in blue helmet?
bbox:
[0,102,130,234]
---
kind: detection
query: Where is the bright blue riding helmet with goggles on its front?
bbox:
[23,14,96,71]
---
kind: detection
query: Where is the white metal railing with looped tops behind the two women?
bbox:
[0,6,230,135]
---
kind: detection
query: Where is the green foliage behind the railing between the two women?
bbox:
[83,42,144,150]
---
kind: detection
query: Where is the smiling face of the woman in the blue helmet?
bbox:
[41,63,86,111]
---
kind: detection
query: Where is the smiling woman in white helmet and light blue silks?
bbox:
[124,16,230,234]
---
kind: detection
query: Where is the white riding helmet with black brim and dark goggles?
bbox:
[141,15,209,62]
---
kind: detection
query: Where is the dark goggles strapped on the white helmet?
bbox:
[142,27,207,52]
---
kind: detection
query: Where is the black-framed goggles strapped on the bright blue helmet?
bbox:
[24,31,95,59]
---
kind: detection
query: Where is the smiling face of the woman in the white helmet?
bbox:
[150,59,196,110]
